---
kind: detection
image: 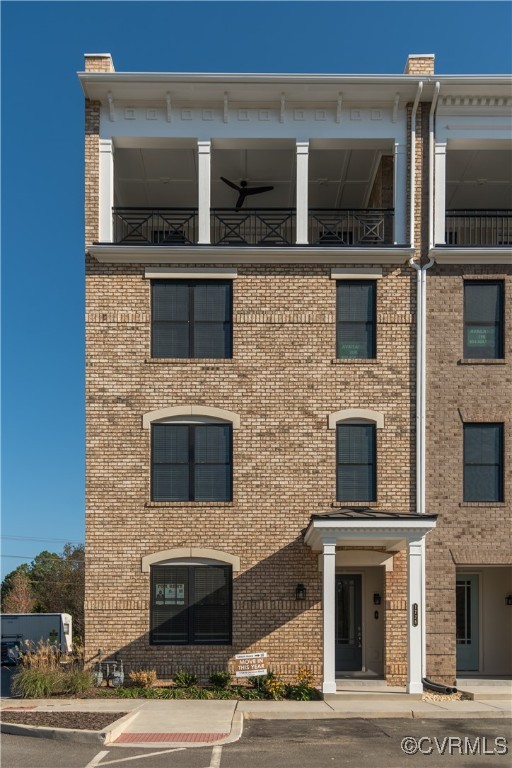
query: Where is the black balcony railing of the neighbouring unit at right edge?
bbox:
[446,210,512,248]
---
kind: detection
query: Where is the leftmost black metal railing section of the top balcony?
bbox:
[112,208,197,245]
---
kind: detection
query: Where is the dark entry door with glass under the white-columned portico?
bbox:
[335,573,363,672]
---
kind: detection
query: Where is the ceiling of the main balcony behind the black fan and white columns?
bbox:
[114,146,383,209]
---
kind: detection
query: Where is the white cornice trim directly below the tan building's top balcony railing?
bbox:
[87,245,414,264]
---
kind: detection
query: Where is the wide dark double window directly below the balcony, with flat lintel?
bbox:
[151,280,232,358]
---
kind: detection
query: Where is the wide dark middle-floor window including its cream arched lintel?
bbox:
[143,405,240,501]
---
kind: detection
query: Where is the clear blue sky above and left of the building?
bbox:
[1,0,512,577]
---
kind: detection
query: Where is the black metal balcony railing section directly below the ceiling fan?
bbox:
[210,208,295,246]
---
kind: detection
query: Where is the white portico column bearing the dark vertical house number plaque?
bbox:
[407,539,424,693]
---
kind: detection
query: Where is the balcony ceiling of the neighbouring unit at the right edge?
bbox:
[446,149,512,210]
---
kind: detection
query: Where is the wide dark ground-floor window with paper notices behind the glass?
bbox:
[151,565,232,645]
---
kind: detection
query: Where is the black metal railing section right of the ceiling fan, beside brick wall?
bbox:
[309,208,394,247]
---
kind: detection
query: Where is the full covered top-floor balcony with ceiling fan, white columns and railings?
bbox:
[109,139,405,248]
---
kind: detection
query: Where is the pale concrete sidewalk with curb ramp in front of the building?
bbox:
[2,688,512,747]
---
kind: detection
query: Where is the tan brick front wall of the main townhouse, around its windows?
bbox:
[86,262,415,676]
